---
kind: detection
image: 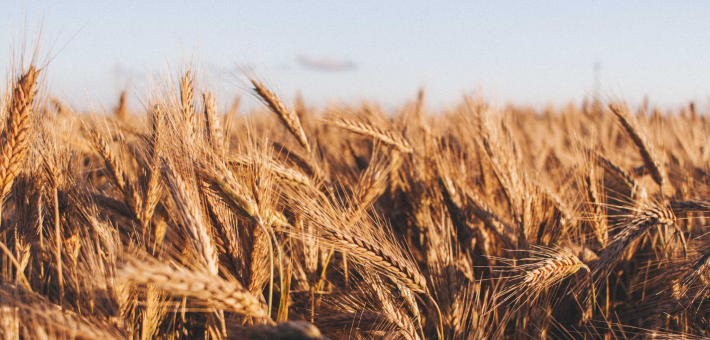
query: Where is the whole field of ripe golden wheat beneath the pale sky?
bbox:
[0,56,710,340]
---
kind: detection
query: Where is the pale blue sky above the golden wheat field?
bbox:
[0,0,710,108]
